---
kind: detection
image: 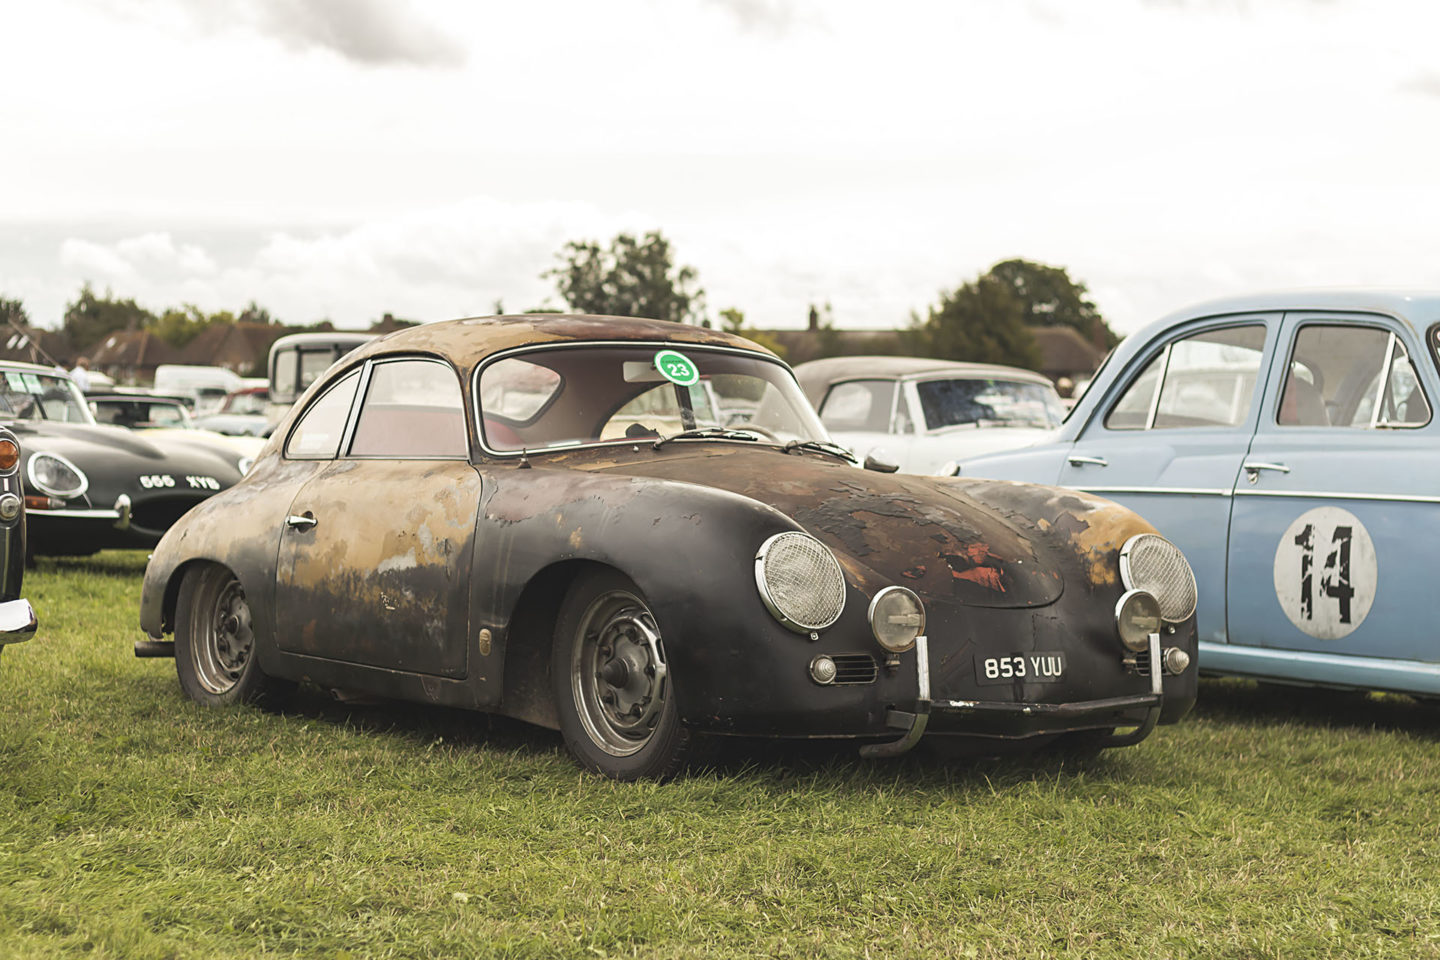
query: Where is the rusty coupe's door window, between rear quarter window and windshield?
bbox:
[350,360,468,459]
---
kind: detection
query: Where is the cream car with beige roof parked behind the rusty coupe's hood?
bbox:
[795,357,1066,474]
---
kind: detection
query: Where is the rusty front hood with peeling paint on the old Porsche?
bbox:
[577,443,1064,607]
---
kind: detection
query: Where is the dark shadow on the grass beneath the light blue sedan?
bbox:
[1191,679,1440,741]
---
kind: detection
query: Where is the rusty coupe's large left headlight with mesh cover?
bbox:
[755,531,845,633]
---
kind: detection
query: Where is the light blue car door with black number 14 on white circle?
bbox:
[1228,312,1440,664]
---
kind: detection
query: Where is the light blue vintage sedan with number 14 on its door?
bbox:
[956,292,1440,695]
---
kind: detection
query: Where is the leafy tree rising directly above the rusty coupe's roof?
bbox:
[540,230,706,324]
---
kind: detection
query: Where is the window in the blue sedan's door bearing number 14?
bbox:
[1276,324,1430,429]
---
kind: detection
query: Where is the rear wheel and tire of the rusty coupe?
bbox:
[176,564,279,707]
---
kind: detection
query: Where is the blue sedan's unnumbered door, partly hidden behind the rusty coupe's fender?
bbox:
[1058,314,1280,642]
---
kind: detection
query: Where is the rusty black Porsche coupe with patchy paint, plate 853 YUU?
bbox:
[137,315,1195,779]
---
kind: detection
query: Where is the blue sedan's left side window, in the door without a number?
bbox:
[1104,324,1264,430]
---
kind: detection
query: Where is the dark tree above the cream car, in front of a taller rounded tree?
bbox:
[904,273,1040,370]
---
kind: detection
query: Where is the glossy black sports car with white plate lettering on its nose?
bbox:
[0,361,245,554]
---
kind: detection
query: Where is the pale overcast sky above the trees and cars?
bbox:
[0,0,1440,332]
